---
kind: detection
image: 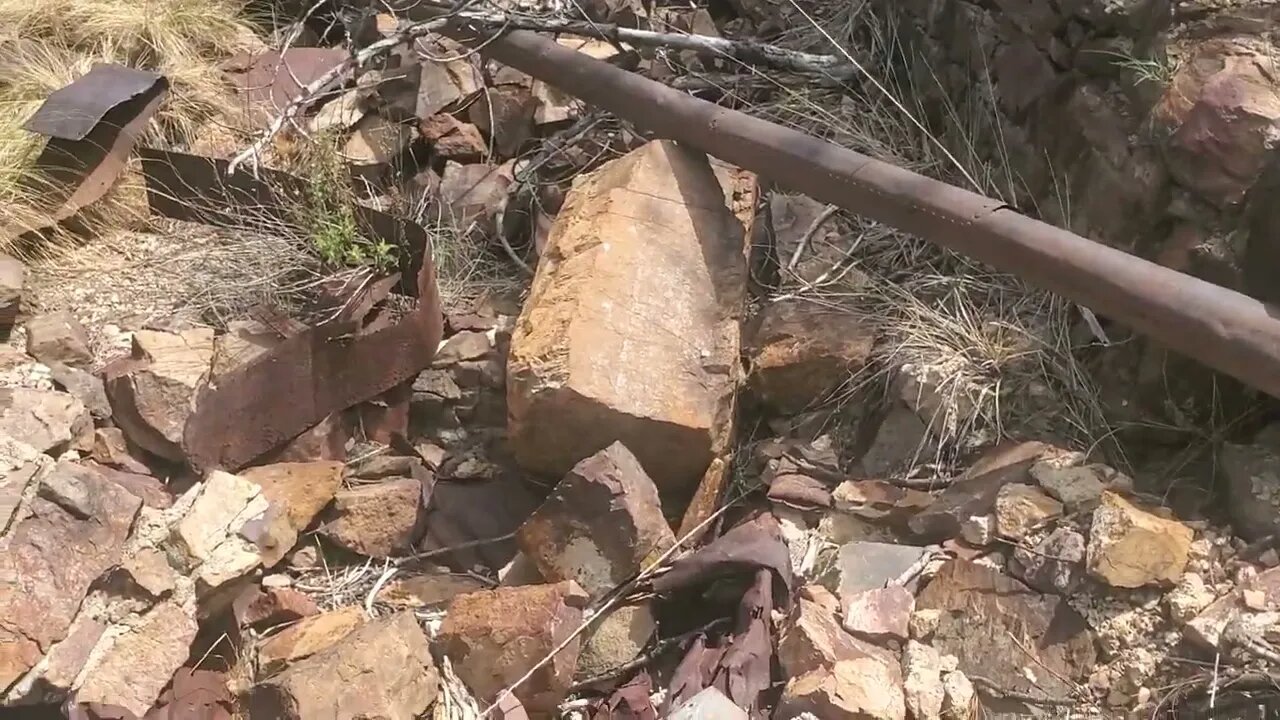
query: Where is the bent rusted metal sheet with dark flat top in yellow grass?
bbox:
[5,63,169,234]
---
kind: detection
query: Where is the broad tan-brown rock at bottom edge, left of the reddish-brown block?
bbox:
[247,611,440,720]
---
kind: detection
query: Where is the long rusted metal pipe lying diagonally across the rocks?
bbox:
[445,26,1280,397]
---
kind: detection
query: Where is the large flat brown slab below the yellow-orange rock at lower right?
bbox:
[915,560,1097,697]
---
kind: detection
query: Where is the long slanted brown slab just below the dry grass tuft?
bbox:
[908,442,1053,542]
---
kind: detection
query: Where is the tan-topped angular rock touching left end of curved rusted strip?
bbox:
[102,328,214,461]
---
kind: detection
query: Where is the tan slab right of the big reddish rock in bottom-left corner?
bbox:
[72,601,196,717]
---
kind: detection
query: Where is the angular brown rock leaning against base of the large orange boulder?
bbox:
[516,442,676,596]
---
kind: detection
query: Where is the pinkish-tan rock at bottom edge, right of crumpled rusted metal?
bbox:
[778,588,906,720]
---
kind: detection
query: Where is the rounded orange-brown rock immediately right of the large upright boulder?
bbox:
[746,300,876,413]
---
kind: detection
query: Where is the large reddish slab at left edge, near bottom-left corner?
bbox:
[0,462,142,689]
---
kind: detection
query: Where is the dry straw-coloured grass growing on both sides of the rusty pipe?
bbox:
[711,1,1123,468]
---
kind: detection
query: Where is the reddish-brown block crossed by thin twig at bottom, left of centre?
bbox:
[438,580,588,714]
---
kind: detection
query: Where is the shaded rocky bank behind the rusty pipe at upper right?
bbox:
[870,0,1280,427]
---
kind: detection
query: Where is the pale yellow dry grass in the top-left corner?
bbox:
[0,0,262,249]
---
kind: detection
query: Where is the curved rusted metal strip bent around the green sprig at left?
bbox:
[135,149,444,470]
